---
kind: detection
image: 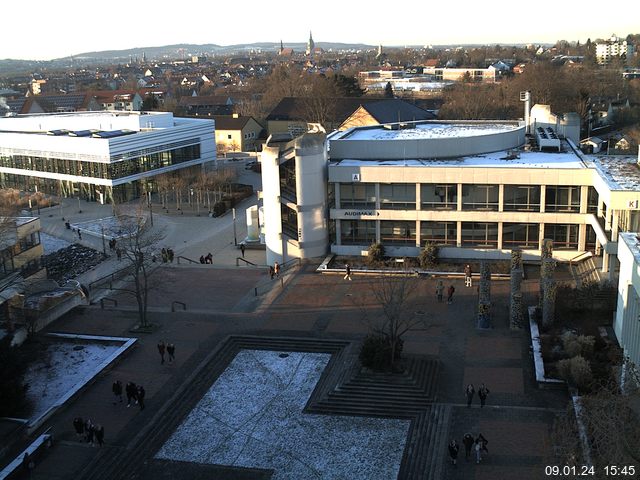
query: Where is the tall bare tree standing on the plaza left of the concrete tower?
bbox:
[114,202,164,327]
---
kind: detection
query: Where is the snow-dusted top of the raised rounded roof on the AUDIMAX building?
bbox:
[330,122,522,141]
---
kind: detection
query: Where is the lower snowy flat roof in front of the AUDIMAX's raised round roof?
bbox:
[330,140,588,169]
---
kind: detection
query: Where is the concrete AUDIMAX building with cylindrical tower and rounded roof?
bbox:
[261,116,640,280]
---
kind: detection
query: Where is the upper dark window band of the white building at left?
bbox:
[0,144,200,179]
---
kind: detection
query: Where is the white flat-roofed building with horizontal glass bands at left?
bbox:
[0,111,216,202]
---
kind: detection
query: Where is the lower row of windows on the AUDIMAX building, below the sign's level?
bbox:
[340,220,595,250]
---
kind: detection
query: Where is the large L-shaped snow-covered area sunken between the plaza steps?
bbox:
[156,350,410,480]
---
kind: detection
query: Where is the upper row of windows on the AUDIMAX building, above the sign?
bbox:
[330,183,598,213]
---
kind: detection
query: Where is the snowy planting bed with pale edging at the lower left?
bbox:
[25,343,121,419]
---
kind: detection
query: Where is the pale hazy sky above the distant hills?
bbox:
[0,0,640,60]
